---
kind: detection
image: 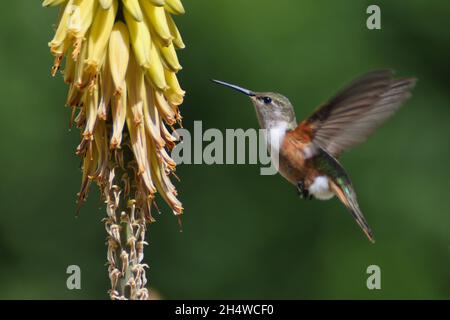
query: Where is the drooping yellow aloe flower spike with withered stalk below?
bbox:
[43,0,184,299]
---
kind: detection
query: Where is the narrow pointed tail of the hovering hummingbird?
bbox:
[331,182,375,243]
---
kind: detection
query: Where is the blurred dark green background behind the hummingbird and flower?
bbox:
[0,0,450,299]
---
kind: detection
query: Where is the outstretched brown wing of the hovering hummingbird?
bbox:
[298,70,416,157]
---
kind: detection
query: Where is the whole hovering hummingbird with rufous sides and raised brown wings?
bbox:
[212,70,416,242]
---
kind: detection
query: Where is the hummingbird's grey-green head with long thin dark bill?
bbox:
[212,80,297,129]
